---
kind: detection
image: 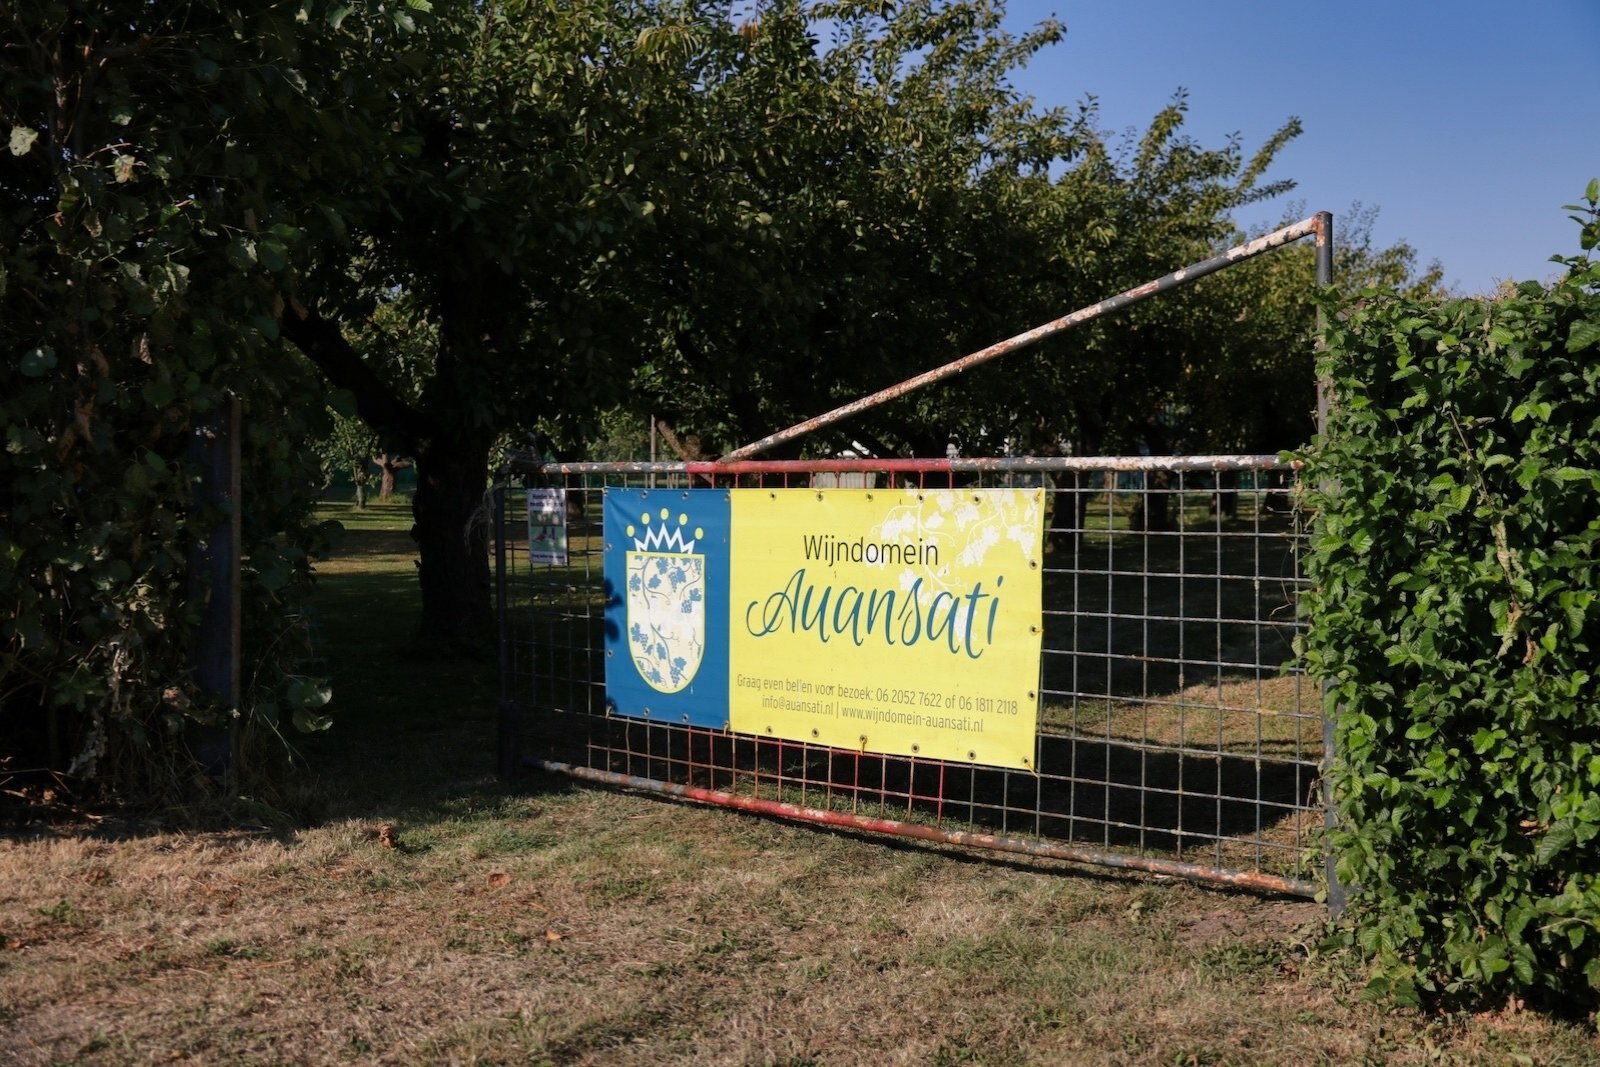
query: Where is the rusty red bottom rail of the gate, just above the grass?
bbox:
[528,758,1317,897]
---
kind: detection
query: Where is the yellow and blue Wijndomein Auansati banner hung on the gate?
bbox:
[606,490,1043,768]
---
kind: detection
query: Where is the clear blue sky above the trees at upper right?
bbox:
[1006,0,1600,293]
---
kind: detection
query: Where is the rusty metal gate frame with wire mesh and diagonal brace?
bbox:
[496,213,1342,910]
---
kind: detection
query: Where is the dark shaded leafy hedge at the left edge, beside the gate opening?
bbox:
[0,0,334,801]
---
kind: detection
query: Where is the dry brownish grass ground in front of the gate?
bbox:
[0,506,1600,1064]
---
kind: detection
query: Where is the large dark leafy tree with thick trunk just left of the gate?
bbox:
[280,3,1094,648]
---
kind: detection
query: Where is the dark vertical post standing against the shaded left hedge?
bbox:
[189,397,242,774]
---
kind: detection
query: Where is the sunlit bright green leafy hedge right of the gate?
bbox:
[1304,182,1600,1011]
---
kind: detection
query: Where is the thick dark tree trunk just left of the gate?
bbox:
[411,432,494,656]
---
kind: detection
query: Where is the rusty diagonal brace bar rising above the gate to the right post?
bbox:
[722,213,1331,462]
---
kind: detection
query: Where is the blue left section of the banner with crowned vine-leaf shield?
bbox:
[605,490,731,729]
